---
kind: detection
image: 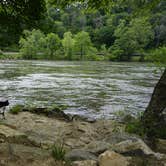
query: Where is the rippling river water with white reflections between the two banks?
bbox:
[0,60,161,118]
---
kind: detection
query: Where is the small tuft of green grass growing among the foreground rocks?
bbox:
[51,144,66,161]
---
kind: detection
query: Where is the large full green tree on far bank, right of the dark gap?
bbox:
[112,18,154,60]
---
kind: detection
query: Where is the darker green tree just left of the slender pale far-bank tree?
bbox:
[45,33,61,59]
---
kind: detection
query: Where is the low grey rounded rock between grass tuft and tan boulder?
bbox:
[65,149,97,161]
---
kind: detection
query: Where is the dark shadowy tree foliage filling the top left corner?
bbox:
[0,0,45,46]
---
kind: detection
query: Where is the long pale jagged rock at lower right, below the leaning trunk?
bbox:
[112,139,161,158]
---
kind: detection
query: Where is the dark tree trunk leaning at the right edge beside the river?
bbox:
[142,69,166,138]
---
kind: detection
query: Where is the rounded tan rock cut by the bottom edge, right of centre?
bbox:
[99,150,129,166]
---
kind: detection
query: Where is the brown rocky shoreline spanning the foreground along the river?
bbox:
[0,111,166,166]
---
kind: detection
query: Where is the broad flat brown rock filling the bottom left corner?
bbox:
[0,143,55,166]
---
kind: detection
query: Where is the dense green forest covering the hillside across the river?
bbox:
[0,0,166,61]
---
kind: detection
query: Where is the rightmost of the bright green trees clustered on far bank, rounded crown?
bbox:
[74,31,92,60]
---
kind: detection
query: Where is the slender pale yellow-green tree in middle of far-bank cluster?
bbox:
[62,32,75,60]
